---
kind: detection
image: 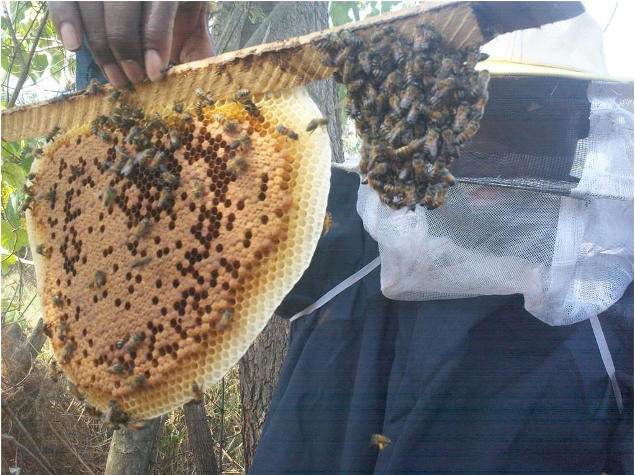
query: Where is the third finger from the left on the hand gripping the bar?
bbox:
[104,2,144,83]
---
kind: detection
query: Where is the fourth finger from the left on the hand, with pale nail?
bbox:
[143,2,178,81]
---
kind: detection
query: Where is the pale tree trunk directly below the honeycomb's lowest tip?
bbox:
[104,417,164,475]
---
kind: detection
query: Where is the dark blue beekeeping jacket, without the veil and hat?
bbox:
[250,166,633,475]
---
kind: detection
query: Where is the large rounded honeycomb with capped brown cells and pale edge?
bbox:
[27,88,330,426]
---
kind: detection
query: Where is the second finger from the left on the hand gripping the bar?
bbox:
[79,2,128,87]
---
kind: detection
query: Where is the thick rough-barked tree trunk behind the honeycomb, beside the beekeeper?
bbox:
[216,2,344,471]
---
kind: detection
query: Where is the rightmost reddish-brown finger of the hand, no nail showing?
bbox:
[171,2,214,63]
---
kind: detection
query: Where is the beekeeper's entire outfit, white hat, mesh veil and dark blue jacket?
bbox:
[250,15,633,475]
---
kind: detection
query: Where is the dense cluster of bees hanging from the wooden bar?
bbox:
[315,25,490,210]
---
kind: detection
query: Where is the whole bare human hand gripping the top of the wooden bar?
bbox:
[49,2,214,87]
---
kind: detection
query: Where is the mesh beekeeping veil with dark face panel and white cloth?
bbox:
[357,15,633,325]
